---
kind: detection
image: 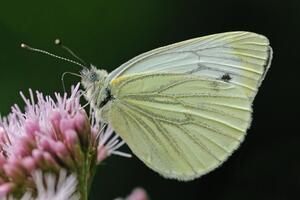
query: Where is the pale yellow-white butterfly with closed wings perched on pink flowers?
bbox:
[22,31,272,181]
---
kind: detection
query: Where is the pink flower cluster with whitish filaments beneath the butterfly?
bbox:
[0,84,130,200]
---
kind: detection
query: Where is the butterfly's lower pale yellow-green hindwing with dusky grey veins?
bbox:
[107,74,251,180]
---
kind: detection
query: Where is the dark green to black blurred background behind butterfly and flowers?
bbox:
[0,0,300,200]
